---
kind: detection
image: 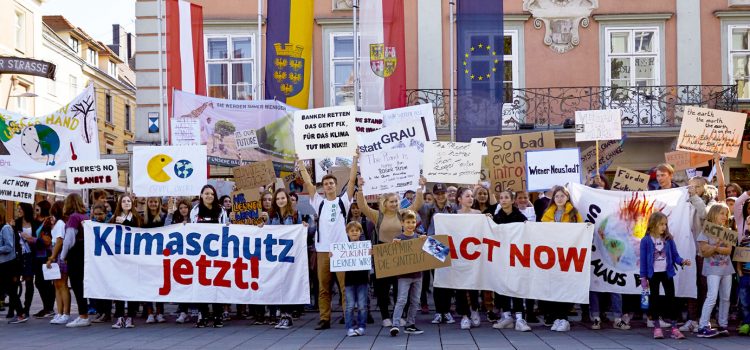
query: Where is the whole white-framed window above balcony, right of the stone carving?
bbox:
[604,27,661,98]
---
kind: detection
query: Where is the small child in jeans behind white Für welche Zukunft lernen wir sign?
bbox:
[344,221,370,337]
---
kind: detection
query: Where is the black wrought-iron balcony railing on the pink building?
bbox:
[406,85,737,134]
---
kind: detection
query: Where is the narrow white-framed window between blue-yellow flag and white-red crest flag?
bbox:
[328,32,354,106]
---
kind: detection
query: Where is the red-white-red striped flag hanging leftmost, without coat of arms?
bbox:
[166,0,206,114]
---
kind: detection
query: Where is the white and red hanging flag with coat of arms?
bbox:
[359,0,406,112]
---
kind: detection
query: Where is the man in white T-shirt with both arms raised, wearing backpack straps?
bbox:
[297,153,359,330]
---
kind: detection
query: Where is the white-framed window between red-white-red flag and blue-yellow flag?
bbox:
[206,35,255,100]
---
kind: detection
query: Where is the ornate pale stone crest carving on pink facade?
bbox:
[523,0,599,53]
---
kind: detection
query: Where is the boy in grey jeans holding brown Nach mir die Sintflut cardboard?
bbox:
[391,210,424,337]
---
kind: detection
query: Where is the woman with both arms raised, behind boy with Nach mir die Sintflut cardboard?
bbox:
[357,177,426,328]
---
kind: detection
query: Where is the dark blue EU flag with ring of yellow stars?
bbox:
[456,0,512,142]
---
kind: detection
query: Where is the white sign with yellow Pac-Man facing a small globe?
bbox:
[131,146,208,197]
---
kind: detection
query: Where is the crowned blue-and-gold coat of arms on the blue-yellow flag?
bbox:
[273,43,305,97]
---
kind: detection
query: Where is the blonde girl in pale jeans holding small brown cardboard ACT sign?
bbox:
[697,203,734,338]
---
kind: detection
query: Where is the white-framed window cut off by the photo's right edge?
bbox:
[729,25,750,100]
